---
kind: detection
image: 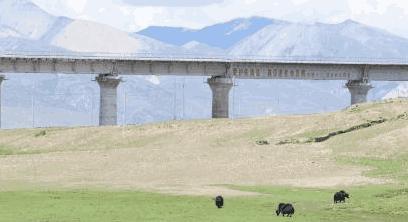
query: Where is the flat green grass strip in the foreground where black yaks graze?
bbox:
[0,186,408,222]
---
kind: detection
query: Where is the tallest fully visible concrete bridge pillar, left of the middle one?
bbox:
[96,74,122,126]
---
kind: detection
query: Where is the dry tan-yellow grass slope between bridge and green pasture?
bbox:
[0,100,408,194]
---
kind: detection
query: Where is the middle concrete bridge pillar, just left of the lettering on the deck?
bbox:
[208,76,233,118]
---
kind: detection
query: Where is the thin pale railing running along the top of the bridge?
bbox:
[0,51,408,65]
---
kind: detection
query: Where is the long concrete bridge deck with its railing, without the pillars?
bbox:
[0,52,408,81]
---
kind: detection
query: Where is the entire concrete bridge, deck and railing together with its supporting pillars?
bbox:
[0,53,408,125]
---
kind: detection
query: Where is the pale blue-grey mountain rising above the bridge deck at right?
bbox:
[230,20,408,59]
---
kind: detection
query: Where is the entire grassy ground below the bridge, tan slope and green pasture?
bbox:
[0,100,408,222]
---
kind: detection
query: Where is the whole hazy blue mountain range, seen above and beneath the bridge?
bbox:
[0,0,408,128]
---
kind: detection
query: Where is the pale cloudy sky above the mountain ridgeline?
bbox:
[32,0,408,38]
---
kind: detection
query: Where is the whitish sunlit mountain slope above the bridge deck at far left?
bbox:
[0,0,179,54]
